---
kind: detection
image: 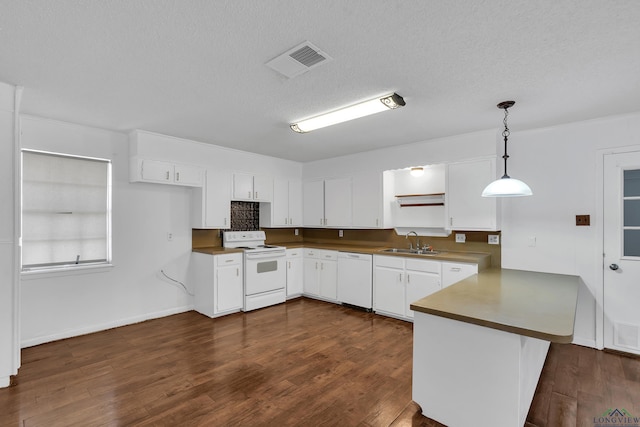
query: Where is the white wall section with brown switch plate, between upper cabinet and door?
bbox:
[502,113,640,346]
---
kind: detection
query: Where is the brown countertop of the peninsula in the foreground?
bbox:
[411,268,580,343]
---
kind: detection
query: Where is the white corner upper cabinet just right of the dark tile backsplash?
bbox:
[260,178,302,227]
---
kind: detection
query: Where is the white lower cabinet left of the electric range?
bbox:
[192,252,243,317]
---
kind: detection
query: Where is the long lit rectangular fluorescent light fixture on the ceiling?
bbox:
[290,93,405,133]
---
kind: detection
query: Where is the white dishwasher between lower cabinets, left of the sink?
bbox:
[338,252,373,310]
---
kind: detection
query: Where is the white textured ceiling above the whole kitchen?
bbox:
[0,0,640,161]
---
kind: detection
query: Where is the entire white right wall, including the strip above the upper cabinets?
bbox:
[303,109,640,346]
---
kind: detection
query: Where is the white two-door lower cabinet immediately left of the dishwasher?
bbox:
[303,248,338,302]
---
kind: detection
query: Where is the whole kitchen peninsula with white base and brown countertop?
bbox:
[411,268,580,427]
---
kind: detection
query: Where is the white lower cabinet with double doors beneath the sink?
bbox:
[373,255,441,319]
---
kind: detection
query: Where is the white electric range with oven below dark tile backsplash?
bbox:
[222,231,287,311]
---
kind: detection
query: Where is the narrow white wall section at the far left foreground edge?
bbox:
[0,82,20,387]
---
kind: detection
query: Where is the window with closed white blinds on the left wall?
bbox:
[22,150,111,271]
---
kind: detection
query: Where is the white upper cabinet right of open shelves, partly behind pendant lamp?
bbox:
[446,158,500,231]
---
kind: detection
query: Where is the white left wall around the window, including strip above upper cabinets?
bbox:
[21,116,302,346]
